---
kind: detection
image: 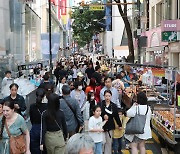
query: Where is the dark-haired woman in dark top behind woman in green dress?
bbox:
[2,83,26,115]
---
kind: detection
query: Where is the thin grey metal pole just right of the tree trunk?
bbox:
[137,0,141,64]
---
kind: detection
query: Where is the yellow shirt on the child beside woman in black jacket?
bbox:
[113,115,129,138]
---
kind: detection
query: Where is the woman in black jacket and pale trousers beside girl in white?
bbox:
[101,90,122,154]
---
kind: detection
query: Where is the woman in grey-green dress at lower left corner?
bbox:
[0,100,31,154]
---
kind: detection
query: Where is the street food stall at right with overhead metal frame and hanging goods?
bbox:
[114,62,180,152]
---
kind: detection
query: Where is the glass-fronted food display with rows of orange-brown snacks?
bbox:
[151,104,180,145]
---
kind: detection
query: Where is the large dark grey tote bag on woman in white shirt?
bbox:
[125,106,149,135]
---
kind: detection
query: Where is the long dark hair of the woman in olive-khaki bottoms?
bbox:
[47,93,60,121]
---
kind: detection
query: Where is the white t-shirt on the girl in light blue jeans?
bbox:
[88,116,103,143]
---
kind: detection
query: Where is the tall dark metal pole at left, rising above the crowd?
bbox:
[49,0,53,73]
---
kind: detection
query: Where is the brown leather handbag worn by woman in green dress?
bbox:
[5,122,26,154]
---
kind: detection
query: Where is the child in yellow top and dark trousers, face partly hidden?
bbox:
[113,111,128,154]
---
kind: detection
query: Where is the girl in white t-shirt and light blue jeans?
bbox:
[88,105,106,154]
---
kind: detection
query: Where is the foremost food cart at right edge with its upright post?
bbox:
[152,68,180,153]
